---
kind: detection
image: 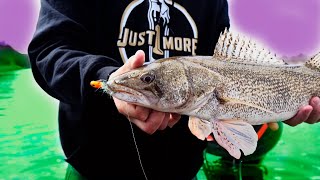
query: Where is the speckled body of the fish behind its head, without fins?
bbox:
[174,56,320,125]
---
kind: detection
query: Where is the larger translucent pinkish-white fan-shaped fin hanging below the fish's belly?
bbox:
[212,120,258,159]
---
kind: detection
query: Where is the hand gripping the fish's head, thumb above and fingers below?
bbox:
[109,50,181,134]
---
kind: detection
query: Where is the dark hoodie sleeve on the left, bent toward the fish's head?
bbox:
[28,0,122,104]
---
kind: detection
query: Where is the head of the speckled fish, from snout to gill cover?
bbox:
[106,58,190,112]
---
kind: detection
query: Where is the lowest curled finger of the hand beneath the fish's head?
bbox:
[131,110,165,134]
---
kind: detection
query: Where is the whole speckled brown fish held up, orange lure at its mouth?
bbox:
[91,31,320,159]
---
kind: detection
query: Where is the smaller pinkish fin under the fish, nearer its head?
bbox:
[188,117,212,140]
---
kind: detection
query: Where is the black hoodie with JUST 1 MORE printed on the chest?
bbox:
[28,0,229,179]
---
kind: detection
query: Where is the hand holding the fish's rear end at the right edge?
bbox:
[268,97,320,130]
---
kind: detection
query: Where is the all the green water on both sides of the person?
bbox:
[0,69,320,180]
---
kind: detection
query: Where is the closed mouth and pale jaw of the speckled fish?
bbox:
[105,82,150,106]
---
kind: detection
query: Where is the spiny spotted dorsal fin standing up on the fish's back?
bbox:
[213,29,286,65]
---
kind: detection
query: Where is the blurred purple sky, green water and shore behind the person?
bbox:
[0,0,320,180]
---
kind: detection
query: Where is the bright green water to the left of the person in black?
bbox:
[0,69,66,179]
